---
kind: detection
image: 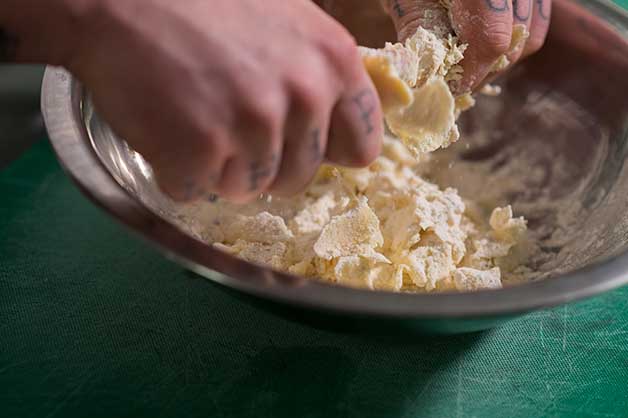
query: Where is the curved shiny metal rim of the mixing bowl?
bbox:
[41,0,628,318]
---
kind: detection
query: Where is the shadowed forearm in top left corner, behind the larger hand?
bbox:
[0,0,97,65]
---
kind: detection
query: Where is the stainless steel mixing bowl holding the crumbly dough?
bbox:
[42,1,628,333]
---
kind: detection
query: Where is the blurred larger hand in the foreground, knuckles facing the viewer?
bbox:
[63,0,383,202]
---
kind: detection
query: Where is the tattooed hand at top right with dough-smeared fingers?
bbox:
[381,0,552,93]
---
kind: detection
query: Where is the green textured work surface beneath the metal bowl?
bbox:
[0,142,628,418]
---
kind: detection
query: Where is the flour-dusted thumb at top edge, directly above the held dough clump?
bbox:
[381,0,451,42]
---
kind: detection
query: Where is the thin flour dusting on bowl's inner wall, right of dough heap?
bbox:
[421,90,608,285]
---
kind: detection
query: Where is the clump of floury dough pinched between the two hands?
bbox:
[361,28,466,155]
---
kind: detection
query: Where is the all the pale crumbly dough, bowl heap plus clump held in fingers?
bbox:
[173,28,526,292]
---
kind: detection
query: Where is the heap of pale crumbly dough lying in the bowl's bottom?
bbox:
[181,137,526,292]
